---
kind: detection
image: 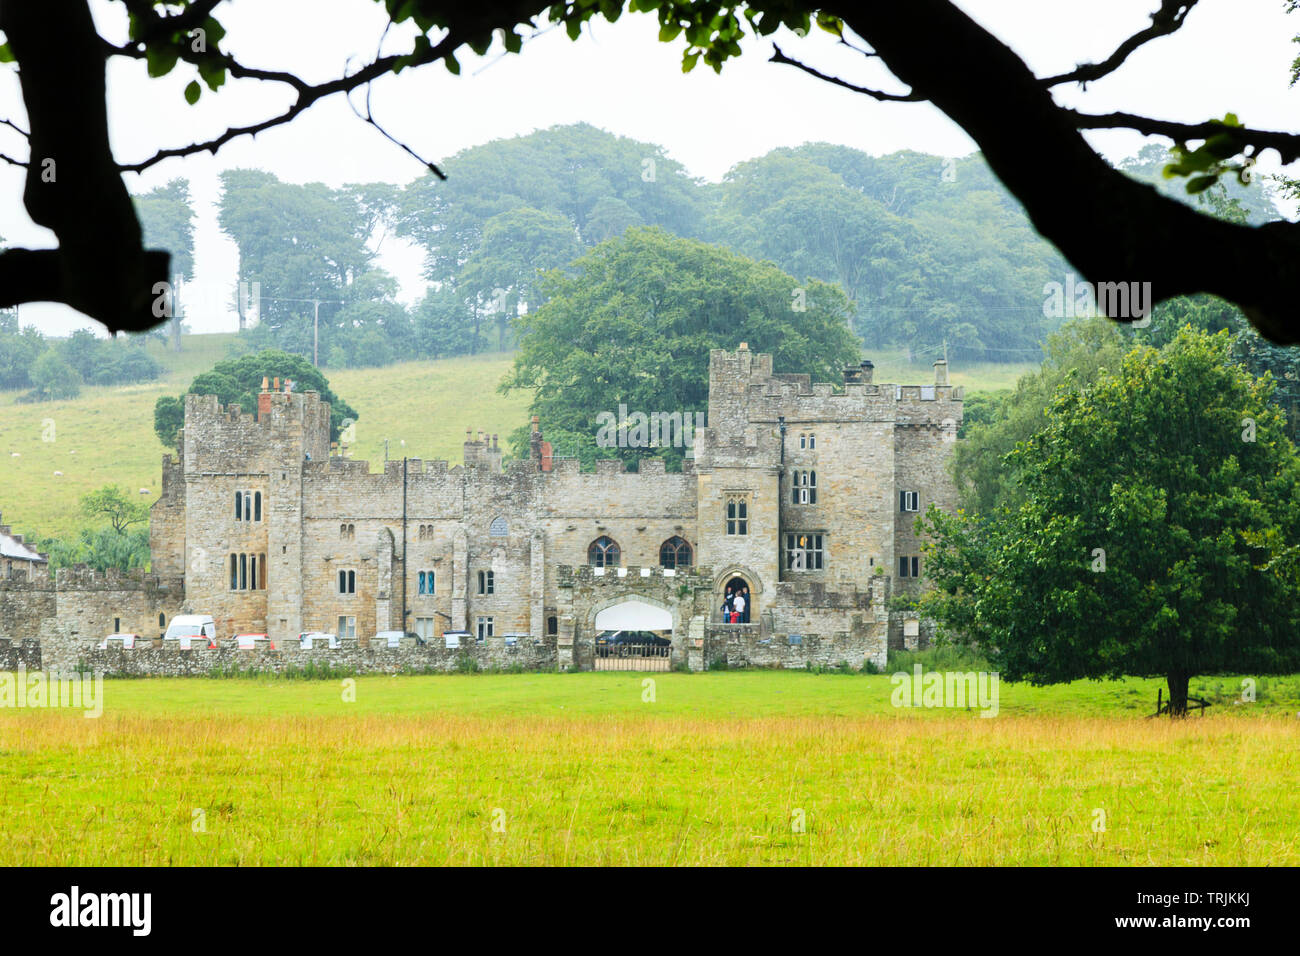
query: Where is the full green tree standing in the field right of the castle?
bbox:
[918,329,1300,714]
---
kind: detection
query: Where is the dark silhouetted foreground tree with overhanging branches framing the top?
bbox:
[0,0,1300,343]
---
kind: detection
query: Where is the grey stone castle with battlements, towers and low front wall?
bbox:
[0,345,962,672]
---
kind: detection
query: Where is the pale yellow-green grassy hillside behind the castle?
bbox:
[0,334,1031,546]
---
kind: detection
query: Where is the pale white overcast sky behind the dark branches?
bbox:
[0,0,1300,334]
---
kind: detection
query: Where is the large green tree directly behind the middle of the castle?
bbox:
[502,226,858,460]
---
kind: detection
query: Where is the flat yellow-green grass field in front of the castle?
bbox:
[0,671,1300,865]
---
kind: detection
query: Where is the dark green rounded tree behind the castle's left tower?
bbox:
[153,349,358,450]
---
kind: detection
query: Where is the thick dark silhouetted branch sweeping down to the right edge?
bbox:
[831,0,1300,343]
